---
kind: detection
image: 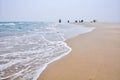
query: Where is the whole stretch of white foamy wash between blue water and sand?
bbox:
[0,24,94,80]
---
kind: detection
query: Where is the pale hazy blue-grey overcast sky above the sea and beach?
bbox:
[0,0,120,22]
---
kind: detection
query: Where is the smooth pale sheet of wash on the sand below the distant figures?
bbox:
[57,24,95,39]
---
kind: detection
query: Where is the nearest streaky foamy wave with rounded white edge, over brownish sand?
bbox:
[0,33,69,80]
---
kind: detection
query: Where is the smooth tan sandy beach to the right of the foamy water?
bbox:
[38,23,120,80]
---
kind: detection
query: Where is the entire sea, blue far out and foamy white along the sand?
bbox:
[0,22,94,80]
